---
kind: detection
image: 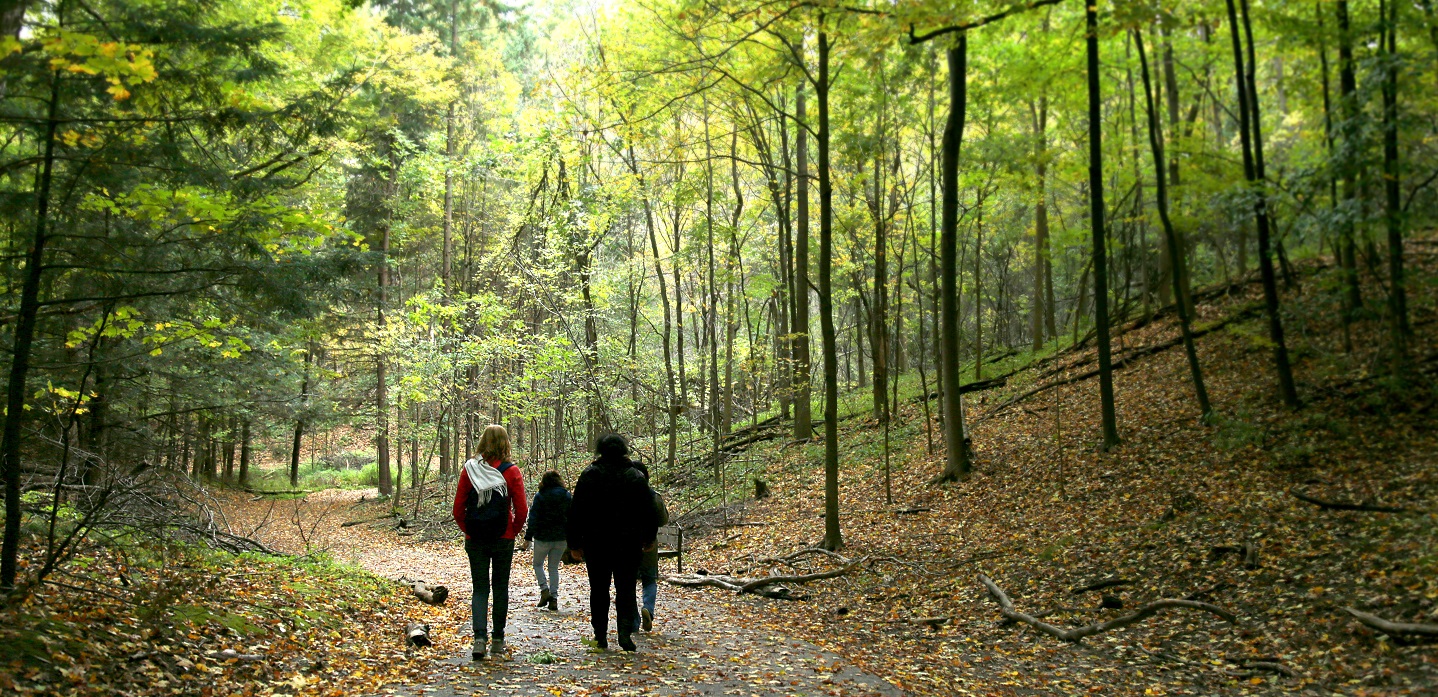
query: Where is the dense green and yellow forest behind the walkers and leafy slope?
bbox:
[0,0,1438,640]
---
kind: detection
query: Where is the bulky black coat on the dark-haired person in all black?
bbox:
[568,458,659,553]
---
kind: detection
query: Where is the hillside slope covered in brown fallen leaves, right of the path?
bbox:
[676,240,1438,694]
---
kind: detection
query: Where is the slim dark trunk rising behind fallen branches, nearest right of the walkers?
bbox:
[814,28,844,552]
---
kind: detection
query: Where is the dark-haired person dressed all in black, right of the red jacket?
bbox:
[568,434,659,651]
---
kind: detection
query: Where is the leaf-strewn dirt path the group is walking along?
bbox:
[229,491,903,697]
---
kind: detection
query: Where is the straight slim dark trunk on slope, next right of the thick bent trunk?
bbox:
[1084,0,1119,448]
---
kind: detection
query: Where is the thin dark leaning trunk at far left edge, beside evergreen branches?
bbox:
[0,69,60,589]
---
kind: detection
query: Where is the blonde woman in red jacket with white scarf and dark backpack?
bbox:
[454,424,529,661]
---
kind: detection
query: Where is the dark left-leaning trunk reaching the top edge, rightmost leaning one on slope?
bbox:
[1227,0,1299,408]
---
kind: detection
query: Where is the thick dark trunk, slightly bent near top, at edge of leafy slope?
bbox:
[938,32,972,481]
